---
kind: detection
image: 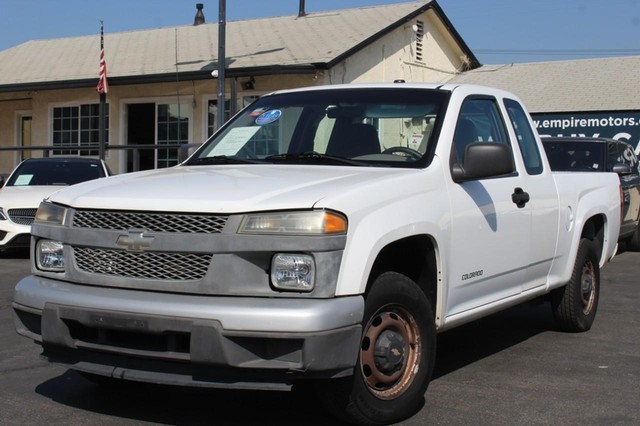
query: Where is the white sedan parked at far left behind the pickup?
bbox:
[0,157,111,251]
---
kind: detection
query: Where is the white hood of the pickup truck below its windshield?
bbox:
[50,164,415,213]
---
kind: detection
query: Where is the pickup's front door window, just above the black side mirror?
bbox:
[453,97,509,164]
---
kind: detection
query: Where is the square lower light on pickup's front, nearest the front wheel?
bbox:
[271,253,316,291]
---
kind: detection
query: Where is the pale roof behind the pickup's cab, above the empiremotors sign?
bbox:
[449,56,640,113]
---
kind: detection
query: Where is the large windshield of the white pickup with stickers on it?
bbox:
[188,88,448,167]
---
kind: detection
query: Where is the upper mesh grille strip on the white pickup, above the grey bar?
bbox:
[73,210,229,234]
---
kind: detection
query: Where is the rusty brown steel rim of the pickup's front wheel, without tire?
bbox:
[360,306,422,399]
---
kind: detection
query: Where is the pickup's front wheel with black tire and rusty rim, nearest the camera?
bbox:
[320,272,436,425]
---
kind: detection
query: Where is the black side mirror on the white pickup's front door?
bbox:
[451,142,516,183]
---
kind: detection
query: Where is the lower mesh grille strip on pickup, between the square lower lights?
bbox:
[74,247,212,281]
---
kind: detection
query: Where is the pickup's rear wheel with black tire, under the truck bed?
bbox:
[551,238,600,332]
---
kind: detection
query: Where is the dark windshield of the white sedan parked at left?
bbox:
[7,160,105,186]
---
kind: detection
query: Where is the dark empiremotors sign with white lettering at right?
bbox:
[531,111,640,153]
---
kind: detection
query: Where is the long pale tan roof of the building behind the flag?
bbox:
[0,0,435,88]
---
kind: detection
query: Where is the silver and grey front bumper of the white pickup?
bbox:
[13,276,364,389]
